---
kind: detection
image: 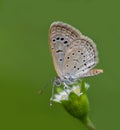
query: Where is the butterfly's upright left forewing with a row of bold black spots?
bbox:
[49,22,81,78]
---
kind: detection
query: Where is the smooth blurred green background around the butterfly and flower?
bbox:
[0,0,120,130]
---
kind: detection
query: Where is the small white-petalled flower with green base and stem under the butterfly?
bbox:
[53,81,96,130]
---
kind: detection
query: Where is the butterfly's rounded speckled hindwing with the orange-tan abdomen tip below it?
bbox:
[63,31,102,79]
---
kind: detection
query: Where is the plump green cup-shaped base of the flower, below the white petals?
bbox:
[62,92,89,120]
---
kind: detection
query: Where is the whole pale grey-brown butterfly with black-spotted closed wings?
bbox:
[49,22,103,87]
